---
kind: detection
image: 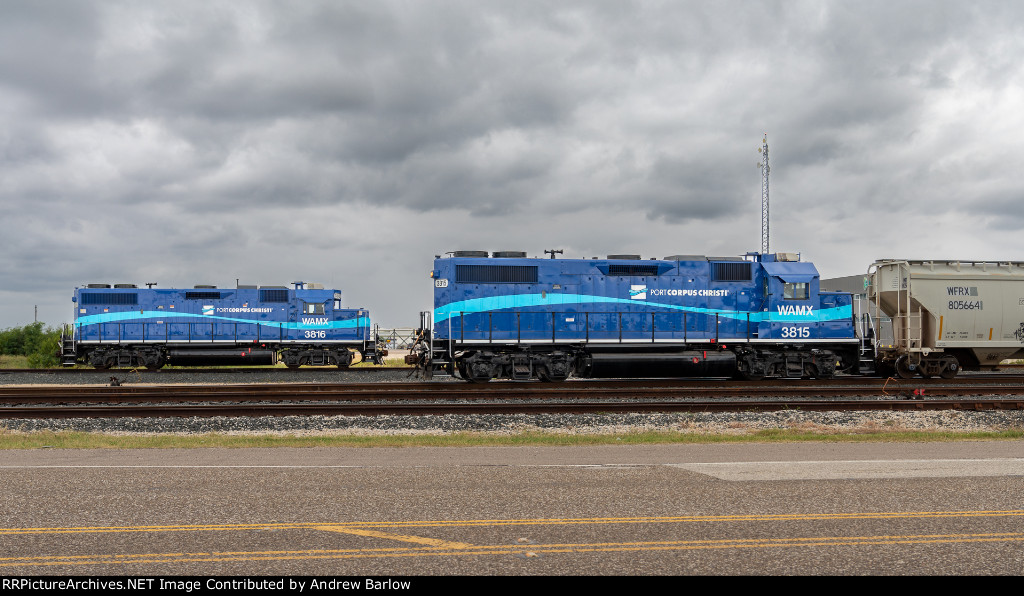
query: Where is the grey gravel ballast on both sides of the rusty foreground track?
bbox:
[0,370,1024,436]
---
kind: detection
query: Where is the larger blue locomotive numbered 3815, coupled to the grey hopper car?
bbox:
[408,251,859,382]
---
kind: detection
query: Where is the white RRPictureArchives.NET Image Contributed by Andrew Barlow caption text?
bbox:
[0,578,413,593]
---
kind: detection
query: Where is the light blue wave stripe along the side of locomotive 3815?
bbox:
[434,294,853,323]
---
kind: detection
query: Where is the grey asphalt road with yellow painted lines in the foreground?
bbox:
[0,441,1024,577]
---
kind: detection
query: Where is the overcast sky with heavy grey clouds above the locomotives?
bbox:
[0,0,1024,328]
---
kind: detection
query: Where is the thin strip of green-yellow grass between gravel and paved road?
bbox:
[0,423,1024,450]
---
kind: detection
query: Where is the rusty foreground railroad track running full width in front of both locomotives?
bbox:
[0,378,1024,419]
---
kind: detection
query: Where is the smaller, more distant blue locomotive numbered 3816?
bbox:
[62,282,386,370]
